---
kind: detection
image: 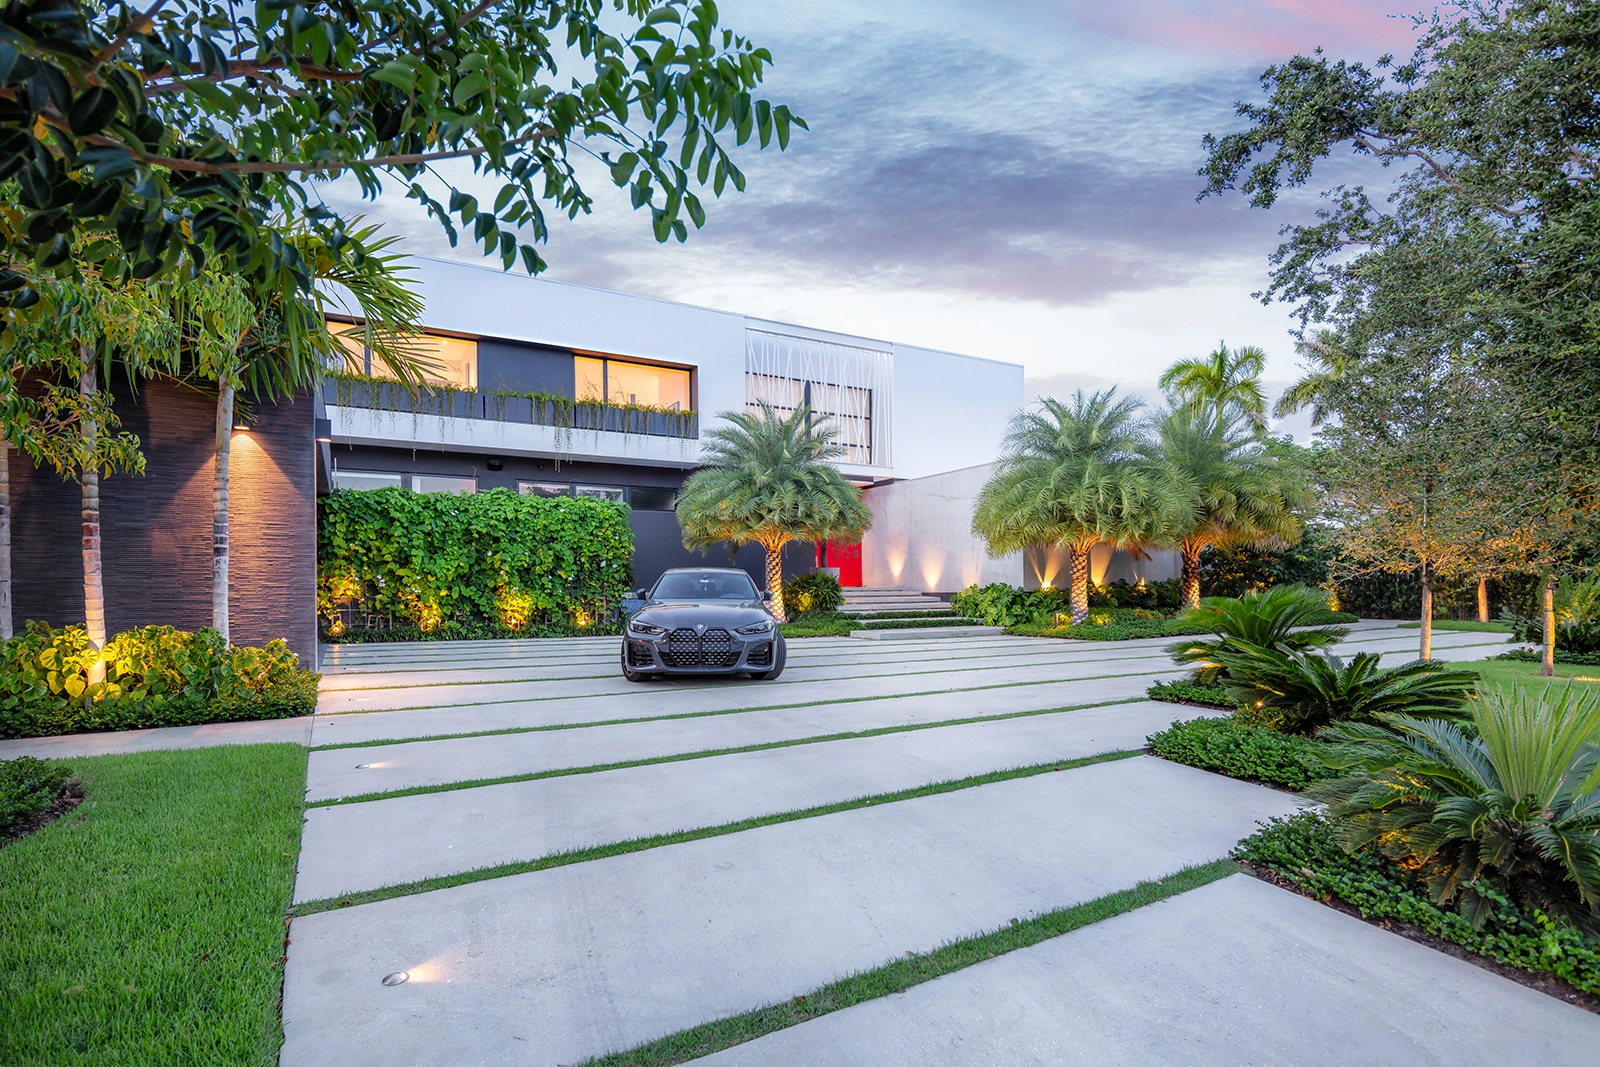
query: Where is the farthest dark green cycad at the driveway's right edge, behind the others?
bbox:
[1166,585,1350,685]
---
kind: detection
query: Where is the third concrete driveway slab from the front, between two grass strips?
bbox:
[294,702,1221,902]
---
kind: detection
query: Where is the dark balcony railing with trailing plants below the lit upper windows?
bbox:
[322,374,699,440]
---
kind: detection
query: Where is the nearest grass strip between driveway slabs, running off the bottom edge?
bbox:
[578,859,1240,1067]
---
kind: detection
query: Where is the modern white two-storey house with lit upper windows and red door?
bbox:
[322,259,1027,592]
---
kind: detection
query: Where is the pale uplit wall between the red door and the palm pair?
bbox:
[861,464,1022,592]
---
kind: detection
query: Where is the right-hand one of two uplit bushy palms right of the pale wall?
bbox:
[1155,403,1310,608]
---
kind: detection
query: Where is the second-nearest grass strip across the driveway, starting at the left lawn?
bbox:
[293,749,1144,915]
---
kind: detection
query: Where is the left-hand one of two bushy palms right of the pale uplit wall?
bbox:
[973,389,1170,624]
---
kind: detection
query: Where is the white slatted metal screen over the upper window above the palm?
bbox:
[744,330,894,467]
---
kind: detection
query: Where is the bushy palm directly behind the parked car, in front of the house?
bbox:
[678,403,872,622]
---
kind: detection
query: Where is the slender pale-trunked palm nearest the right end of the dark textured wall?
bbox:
[174,227,429,640]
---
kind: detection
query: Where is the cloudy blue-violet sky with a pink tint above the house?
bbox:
[318,0,1413,440]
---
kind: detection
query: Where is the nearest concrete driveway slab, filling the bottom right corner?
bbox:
[694,875,1600,1067]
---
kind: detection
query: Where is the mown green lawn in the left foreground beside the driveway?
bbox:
[0,744,306,1067]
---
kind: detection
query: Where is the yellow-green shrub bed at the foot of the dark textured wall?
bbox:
[0,622,320,737]
